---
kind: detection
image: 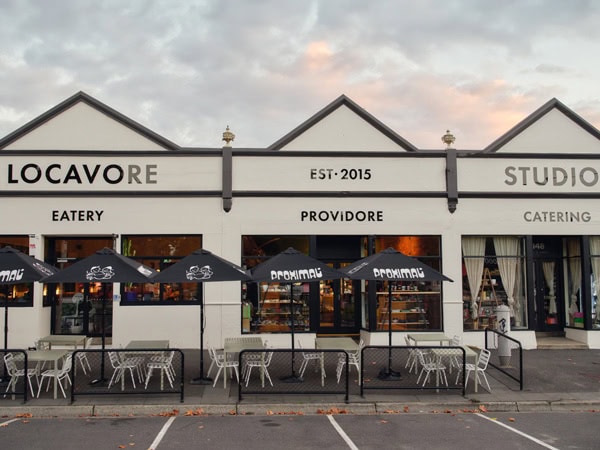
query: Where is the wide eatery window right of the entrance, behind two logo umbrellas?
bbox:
[121,235,202,305]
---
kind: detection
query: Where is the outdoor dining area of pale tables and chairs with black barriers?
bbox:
[0,333,510,401]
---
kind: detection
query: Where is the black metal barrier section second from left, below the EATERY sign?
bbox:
[71,348,184,402]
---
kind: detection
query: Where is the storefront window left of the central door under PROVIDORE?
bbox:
[242,235,310,333]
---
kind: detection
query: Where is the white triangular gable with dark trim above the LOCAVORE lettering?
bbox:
[0,92,179,151]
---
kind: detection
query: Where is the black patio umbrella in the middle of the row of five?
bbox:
[151,249,252,384]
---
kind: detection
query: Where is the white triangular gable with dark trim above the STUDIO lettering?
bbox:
[483,98,600,154]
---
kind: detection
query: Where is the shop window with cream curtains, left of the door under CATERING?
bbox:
[462,236,527,330]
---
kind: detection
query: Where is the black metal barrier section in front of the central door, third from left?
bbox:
[237,349,349,402]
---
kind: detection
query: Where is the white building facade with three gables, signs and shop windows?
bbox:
[0,93,600,348]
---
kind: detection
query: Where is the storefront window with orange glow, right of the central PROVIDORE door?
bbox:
[366,236,442,331]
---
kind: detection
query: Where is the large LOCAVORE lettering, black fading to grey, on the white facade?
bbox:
[7,163,158,185]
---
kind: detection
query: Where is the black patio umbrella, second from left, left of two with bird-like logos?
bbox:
[42,247,156,382]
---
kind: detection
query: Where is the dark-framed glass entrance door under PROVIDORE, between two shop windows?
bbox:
[317,262,360,334]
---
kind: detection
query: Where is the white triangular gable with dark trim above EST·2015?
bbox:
[268,95,417,152]
